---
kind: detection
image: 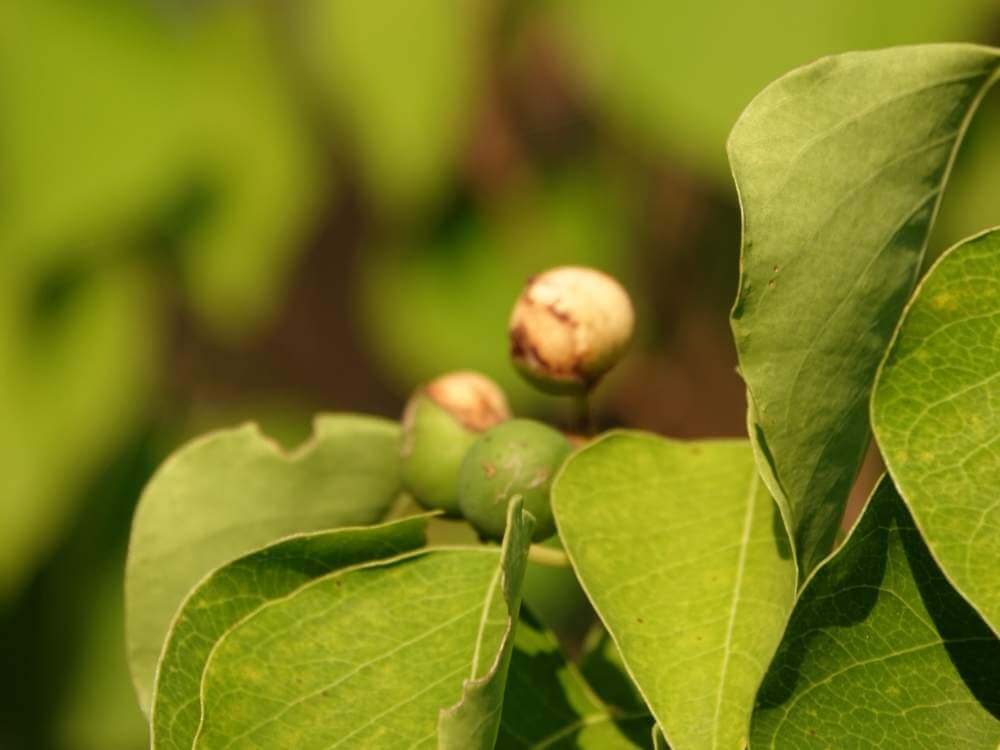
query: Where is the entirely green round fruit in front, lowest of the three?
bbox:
[458,419,572,542]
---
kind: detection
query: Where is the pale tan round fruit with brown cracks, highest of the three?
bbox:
[509,266,635,394]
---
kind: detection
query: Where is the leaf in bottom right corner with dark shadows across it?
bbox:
[751,477,1000,750]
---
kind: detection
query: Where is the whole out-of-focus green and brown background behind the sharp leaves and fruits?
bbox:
[0,0,1000,750]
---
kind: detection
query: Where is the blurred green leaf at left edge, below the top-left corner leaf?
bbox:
[0,268,153,600]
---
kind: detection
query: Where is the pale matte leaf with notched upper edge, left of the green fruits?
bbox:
[125,415,399,710]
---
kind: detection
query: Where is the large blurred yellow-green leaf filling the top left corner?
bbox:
[0,0,320,333]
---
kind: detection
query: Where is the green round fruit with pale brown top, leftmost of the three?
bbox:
[399,372,510,516]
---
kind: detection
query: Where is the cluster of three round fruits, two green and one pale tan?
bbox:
[400,266,635,542]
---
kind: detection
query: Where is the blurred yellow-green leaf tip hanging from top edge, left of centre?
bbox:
[299,0,486,213]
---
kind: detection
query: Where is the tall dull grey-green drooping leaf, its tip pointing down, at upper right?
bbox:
[729,44,1000,580]
